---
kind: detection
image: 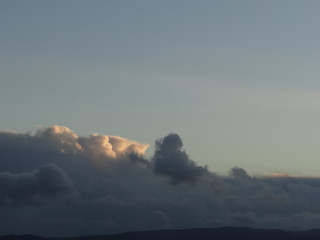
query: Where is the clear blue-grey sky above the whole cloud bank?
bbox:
[0,0,320,176]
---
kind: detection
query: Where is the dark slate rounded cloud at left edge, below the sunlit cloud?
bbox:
[0,163,75,206]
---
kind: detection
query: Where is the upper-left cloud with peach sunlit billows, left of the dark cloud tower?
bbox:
[0,126,148,171]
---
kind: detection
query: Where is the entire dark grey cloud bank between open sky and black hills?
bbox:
[0,126,320,236]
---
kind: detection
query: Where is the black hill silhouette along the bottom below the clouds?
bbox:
[0,227,320,240]
